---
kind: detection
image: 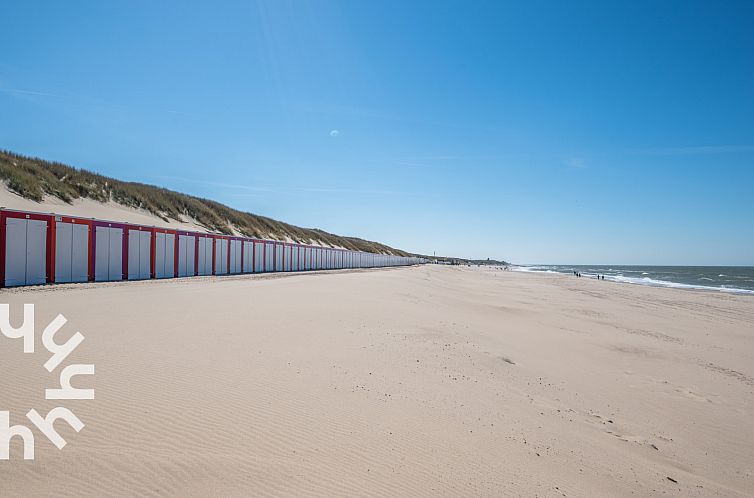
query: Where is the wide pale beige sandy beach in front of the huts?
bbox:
[0,266,754,496]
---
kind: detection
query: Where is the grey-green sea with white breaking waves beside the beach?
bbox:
[511,265,754,295]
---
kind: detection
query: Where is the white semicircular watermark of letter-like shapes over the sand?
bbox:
[0,304,94,460]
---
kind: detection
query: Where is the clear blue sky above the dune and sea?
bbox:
[0,0,754,265]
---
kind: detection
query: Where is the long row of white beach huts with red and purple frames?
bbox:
[0,209,424,287]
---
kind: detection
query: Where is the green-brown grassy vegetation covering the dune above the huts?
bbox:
[0,150,407,256]
